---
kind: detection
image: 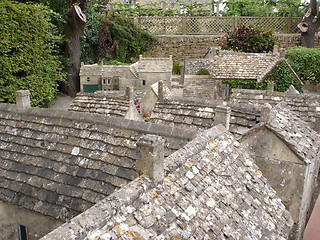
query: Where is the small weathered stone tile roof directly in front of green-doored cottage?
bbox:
[69,91,142,117]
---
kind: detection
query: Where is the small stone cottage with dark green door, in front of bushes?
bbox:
[79,56,172,92]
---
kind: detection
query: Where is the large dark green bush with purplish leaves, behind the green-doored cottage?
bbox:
[81,8,154,63]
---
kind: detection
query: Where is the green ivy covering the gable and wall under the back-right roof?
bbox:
[224,61,303,92]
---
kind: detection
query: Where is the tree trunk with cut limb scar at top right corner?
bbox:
[298,0,320,48]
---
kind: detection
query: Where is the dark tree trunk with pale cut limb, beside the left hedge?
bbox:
[62,5,87,97]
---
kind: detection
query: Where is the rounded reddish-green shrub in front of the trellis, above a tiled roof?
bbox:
[220,25,276,53]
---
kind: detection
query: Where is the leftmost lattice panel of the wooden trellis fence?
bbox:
[138,17,182,34]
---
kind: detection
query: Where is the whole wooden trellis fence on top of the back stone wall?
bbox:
[134,16,300,35]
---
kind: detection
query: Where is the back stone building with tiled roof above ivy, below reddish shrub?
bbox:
[183,48,302,99]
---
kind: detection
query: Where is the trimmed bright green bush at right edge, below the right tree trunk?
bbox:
[285,47,320,84]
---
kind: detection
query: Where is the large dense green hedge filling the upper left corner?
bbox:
[0,0,65,106]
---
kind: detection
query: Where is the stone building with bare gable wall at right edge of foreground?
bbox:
[239,103,320,239]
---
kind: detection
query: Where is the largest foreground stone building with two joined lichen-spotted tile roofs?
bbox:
[0,92,293,239]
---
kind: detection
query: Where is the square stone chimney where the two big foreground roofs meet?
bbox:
[136,135,164,184]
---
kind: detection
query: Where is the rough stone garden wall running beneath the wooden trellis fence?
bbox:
[145,34,320,61]
